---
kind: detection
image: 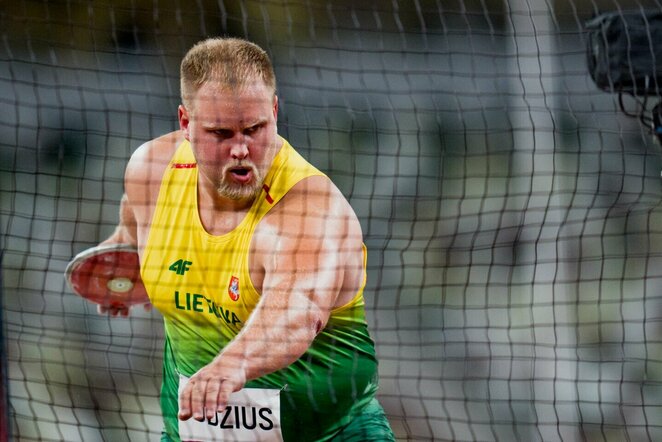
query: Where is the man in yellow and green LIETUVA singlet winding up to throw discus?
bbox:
[104,39,393,441]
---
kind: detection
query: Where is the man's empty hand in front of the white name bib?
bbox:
[178,355,246,421]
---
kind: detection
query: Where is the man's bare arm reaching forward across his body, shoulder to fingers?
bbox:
[180,177,363,420]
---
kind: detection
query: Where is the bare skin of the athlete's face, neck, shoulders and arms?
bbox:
[104,82,364,420]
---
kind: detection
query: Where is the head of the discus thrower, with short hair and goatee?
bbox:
[179,38,279,201]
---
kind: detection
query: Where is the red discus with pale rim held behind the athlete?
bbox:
[64,244,149,308]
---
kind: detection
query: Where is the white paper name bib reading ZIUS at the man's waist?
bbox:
[179,375,283,442]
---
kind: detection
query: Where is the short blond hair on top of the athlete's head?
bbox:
[180,38,276,107]
